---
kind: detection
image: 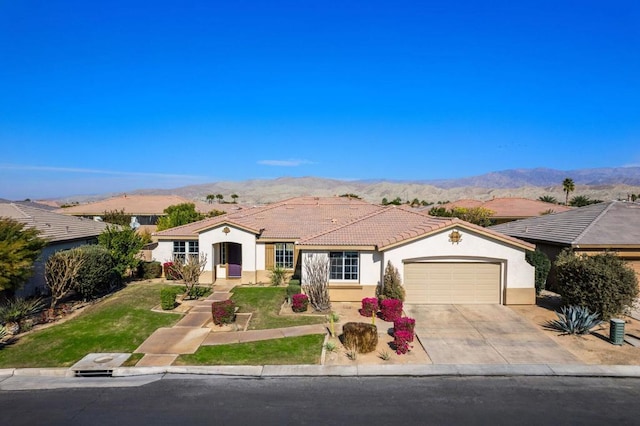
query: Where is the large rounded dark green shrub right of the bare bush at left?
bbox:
[73,245,120,300]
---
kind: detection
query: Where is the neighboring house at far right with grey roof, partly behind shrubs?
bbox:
[490,201,640,284]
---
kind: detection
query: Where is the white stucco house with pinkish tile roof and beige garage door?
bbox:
[153,197,535,304]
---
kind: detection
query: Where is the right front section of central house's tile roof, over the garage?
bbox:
[298,206,529,250]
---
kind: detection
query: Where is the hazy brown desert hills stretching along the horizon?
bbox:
[48,167,640,204]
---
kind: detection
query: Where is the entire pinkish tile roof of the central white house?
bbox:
[154,197,533,248]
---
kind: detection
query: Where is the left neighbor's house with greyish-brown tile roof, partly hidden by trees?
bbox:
[0,203,108,296]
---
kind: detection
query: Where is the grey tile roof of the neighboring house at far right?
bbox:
[491,201,640,247]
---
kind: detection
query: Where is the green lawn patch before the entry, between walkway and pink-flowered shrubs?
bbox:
[231,287,325,330]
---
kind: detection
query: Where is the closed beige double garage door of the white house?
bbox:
[404,263,500,304]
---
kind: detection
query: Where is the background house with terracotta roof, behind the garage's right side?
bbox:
[436,197,571,224]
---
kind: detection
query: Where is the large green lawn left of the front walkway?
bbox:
[0,282,181,368]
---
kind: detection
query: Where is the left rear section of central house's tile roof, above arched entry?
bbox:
[154,197,383,240]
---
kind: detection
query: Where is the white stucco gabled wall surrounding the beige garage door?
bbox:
[384,228,535,304]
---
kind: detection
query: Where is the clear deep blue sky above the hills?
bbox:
[0,0,640,199]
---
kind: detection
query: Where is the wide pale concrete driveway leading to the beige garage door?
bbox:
[404,305,581,364]
